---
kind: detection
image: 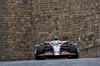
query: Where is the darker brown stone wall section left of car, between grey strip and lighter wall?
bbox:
[5,0,34,60]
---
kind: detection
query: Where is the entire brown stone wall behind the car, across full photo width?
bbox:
[0,0,100,60]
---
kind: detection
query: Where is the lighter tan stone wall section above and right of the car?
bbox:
[33,0,100,49]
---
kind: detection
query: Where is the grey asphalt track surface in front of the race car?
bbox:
[0,58,100,66]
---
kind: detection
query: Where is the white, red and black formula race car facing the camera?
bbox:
[35,40,79,60]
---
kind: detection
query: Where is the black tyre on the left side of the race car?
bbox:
[35,45,46,60]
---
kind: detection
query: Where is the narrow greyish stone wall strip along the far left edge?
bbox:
[0,0,8,60]
